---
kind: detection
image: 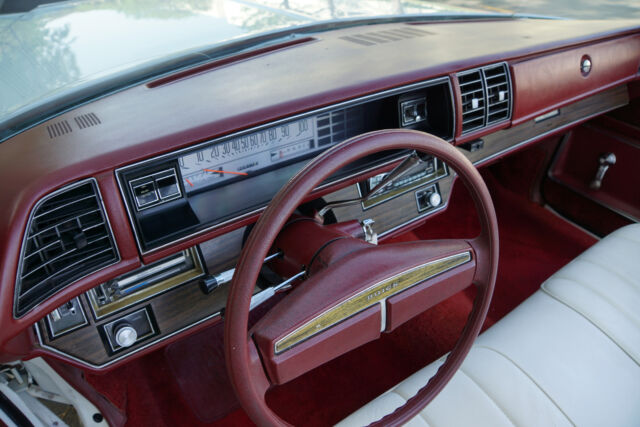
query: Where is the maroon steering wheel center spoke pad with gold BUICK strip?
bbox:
[252,239,476,384]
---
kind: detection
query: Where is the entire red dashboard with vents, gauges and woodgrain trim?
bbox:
[0,19,640,371]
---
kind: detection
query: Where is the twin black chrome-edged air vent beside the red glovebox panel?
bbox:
[458,63,511,133]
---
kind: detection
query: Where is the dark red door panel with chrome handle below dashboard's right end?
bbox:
[544,108,640,234]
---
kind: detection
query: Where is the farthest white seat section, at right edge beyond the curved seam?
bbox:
[542,224,640,363]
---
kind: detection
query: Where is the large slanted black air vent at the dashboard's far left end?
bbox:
[14,179,119,317]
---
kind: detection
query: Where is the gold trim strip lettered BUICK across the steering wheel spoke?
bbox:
[275,251,471,354]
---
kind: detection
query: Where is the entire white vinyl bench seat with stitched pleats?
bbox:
[338,224,640,427]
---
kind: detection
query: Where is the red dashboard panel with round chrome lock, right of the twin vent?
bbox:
[511,36,640,125]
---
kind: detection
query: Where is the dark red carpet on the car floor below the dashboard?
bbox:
[81,158,595,426]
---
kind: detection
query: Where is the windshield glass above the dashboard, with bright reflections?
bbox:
[0,0,640,141]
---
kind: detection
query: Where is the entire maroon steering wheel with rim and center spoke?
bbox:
[225,130,498,426]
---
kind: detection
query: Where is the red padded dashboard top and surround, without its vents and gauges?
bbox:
[0,20,640,368]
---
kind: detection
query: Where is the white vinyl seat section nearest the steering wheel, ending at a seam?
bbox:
[338,348,571,427]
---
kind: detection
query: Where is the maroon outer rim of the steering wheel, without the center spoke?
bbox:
[224,130,498,425]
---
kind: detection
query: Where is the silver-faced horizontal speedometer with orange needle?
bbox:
[178,117,323,193]
